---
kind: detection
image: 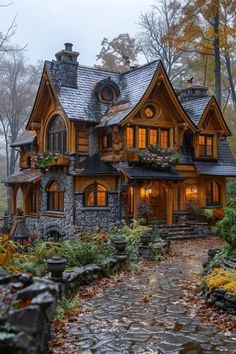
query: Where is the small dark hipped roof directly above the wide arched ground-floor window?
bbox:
[70,155,118,176]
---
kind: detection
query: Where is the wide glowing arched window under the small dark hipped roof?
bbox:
[84,182,108,207]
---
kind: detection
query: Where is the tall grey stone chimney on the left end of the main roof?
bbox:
[55,43,79,88]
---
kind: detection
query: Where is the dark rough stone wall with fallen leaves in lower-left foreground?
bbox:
[0,274,58,354]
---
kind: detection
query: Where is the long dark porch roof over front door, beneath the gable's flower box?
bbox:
[119,163,185,180]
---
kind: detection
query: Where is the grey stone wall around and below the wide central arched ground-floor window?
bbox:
[75,192,120,231]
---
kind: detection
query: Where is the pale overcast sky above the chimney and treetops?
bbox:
[0,0,158,65]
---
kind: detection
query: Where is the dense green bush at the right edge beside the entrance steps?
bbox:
[213,207,236,249]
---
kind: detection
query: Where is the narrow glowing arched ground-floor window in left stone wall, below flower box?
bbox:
[46,181,64,211]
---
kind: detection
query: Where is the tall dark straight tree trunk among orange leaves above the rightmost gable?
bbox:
[213,1,221,108]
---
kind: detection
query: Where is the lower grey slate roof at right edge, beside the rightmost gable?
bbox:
[195,139,236,177]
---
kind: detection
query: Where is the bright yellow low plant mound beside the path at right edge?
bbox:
[205,268,236,294]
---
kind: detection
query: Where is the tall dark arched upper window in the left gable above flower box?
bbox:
[47,116,67,154]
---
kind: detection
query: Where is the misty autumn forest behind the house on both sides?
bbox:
[0,0,236,216]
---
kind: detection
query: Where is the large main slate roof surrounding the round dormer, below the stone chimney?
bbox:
[46,61,160,126]
